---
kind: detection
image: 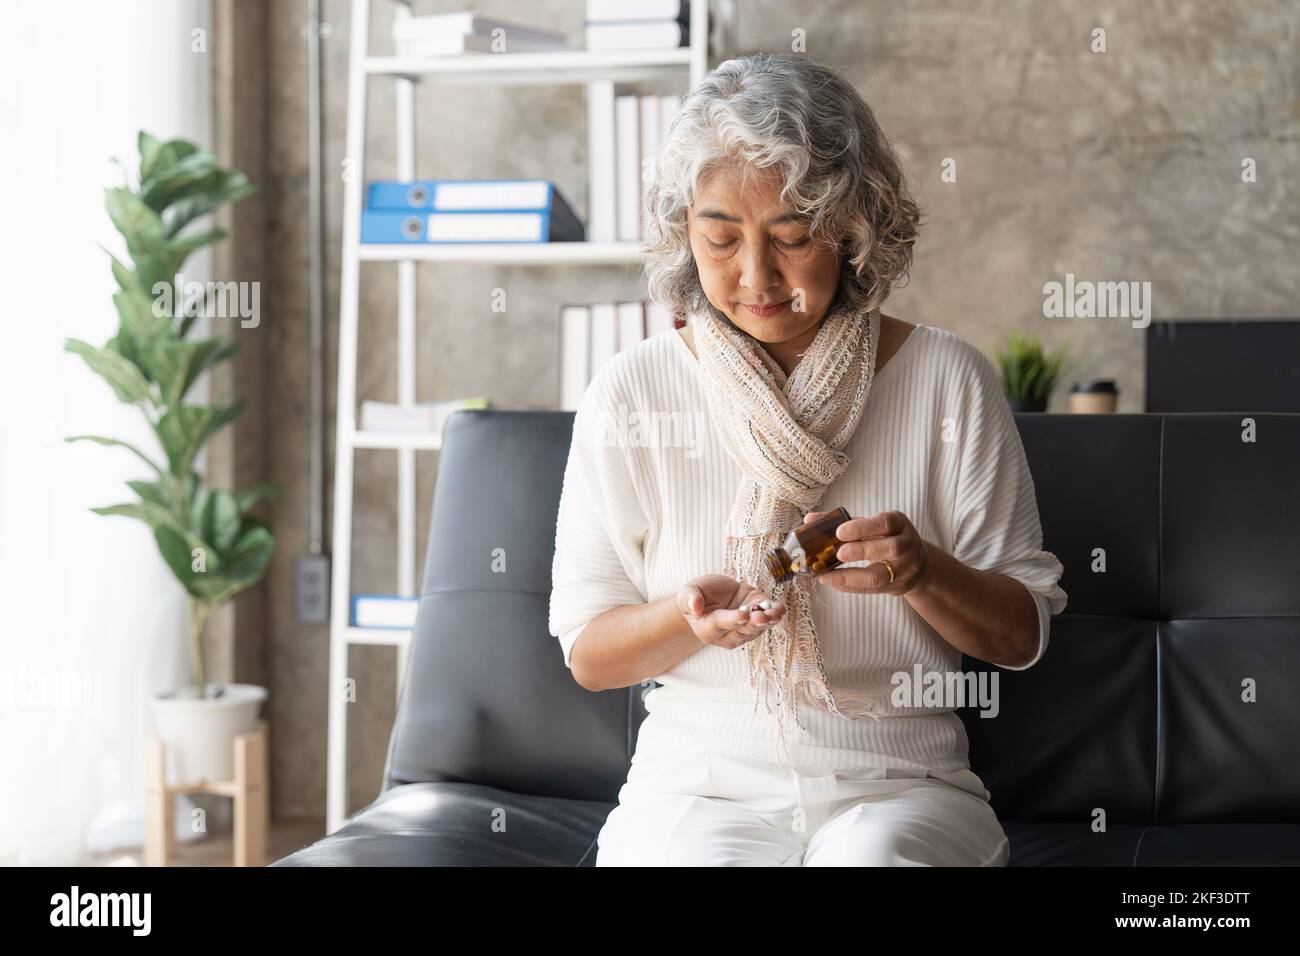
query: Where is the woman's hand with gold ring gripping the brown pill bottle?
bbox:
[803,511,930,596]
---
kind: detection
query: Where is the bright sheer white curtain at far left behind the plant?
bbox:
[0,0,211,865]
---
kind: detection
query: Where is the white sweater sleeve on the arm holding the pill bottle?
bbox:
[953,345,1067,671]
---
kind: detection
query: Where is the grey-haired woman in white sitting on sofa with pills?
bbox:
[550,55,1066,866]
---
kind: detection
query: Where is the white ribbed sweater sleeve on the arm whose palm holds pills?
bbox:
[550,368,649,669]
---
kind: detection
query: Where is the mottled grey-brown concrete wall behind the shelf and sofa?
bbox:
[241,0,1300,817]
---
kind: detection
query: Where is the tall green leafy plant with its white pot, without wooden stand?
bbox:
[64,131,280,786]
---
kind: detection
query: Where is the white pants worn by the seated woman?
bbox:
[595,753,1010,866]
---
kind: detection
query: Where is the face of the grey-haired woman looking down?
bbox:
[686,165,840,351]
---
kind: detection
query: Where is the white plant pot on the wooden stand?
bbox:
[150,684,268,787]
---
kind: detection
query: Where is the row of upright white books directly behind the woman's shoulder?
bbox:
[559,300,686,411]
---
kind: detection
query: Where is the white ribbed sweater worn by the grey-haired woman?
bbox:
[550,325,1066,771]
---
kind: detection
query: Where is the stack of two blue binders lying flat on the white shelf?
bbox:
[361,179,585,242]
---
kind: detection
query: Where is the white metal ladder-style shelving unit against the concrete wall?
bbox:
[325,0,709,832]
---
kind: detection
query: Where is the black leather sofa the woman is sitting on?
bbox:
[273,410,1300,866]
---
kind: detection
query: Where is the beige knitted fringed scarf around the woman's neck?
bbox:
[690,304,880,763]
